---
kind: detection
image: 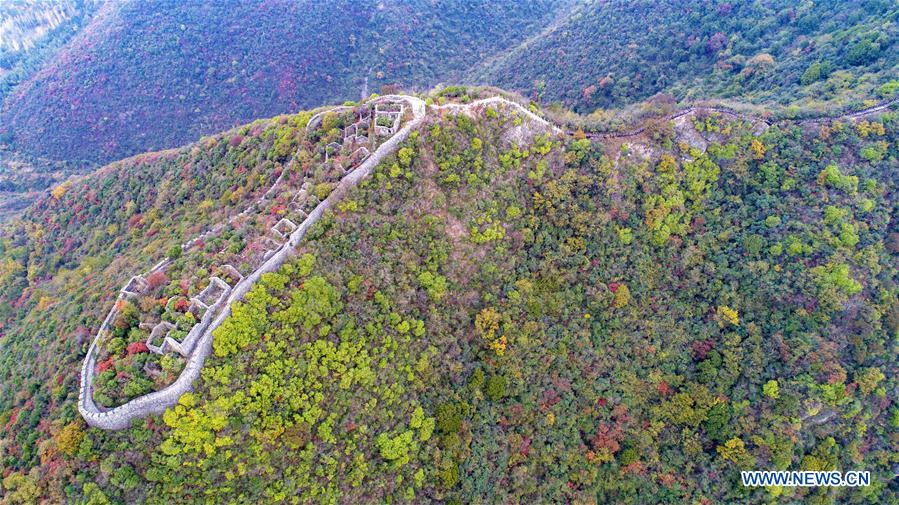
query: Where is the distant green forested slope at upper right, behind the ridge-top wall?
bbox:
[471,0,899,111]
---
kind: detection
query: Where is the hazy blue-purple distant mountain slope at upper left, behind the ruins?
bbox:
[0,0,567,162]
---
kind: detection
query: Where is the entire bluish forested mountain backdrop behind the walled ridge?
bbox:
[0,0,899,222]
